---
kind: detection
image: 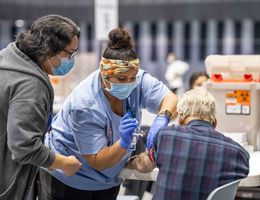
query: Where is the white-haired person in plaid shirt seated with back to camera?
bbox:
[127,88,249,200]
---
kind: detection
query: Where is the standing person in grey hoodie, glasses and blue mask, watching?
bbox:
[0,15,81,200]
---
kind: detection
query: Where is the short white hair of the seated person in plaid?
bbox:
[177,87,216,125]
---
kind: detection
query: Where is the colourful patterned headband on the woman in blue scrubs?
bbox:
[99,57,140,78]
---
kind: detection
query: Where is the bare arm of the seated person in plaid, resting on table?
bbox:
[126,152,156,173]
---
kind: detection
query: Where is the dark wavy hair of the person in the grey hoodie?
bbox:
[16,15,80,65]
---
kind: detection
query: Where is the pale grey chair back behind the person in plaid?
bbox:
[207,179,242,200]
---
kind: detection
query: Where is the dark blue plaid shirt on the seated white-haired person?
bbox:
[153,120,249,200]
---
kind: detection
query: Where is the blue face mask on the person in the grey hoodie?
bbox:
[52,56,74,76]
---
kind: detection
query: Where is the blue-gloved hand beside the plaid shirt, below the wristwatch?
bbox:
[146,115,170,149]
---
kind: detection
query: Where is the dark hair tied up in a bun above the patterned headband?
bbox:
[103,27,137,61]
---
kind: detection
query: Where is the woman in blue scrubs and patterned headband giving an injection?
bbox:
[40,28,177,200]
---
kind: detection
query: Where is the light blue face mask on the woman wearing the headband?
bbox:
[106,81,137,100]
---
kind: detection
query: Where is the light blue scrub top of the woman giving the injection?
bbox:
[45,70,169,190]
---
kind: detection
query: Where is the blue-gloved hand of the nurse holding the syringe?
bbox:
[119,112,138,149]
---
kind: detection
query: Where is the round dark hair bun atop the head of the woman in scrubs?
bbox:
[107,28,134,50]
